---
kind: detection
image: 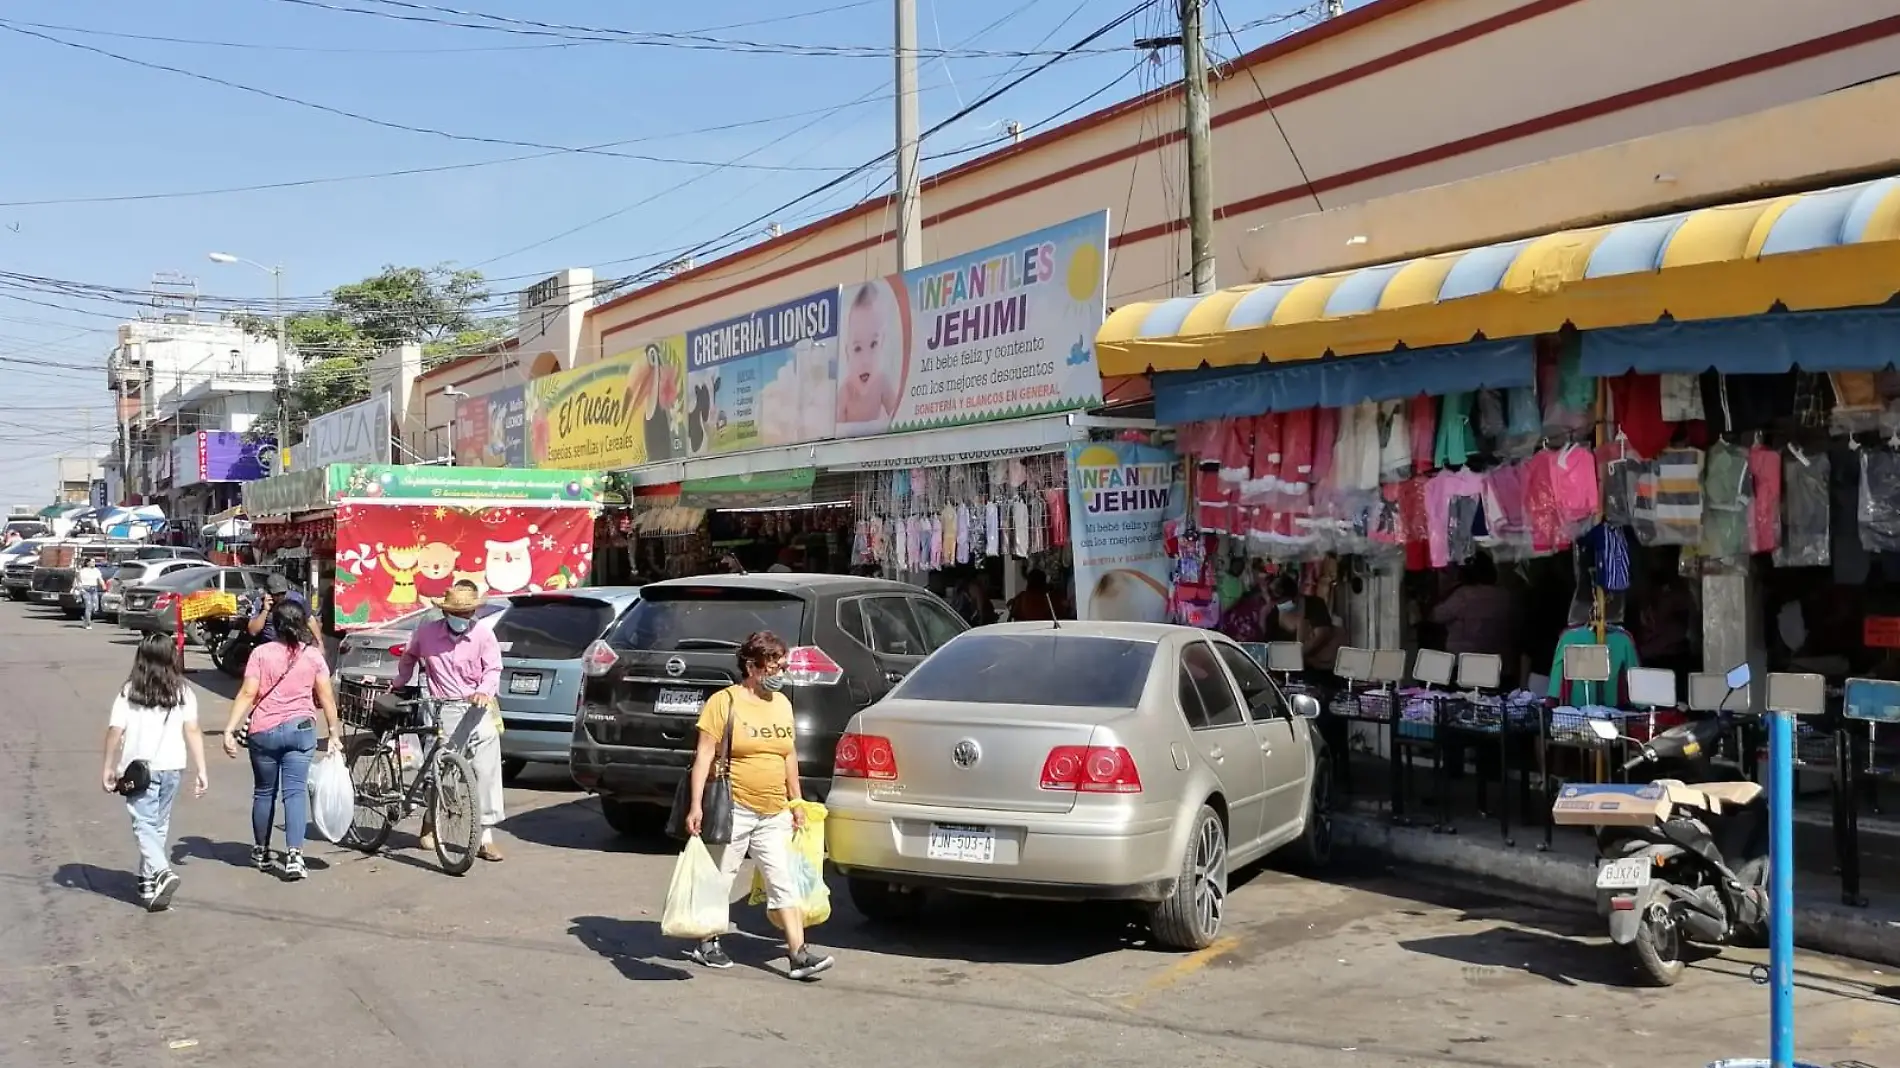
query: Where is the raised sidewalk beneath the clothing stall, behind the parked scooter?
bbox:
[1334,779,1900,965]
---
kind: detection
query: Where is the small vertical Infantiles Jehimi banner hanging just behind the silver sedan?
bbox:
[1068,441,1184,623]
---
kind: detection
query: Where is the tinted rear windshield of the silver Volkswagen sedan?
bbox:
[891,631,1155,709]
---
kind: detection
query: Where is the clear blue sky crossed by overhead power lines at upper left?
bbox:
[0,0,1305,504]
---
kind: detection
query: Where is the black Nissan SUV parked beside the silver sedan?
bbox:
[570,574,967,834]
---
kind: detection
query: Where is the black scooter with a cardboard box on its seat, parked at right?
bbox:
[1550,701,1769,986]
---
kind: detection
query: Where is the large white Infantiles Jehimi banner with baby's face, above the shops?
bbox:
[838,211,1108,437]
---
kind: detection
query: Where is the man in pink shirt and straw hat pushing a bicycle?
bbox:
[395,580,502,861]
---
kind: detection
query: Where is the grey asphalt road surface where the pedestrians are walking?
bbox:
[0,602,1900,1068]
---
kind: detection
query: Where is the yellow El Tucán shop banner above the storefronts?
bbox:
[528,334,686,471]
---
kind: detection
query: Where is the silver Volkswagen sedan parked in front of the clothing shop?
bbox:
[827,623,1332,948]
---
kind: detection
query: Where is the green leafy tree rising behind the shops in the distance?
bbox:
[241,264,513,431]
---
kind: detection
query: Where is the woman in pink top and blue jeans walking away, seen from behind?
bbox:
[224,601,344,880]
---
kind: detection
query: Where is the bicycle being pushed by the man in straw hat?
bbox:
[342,690,483,876]
